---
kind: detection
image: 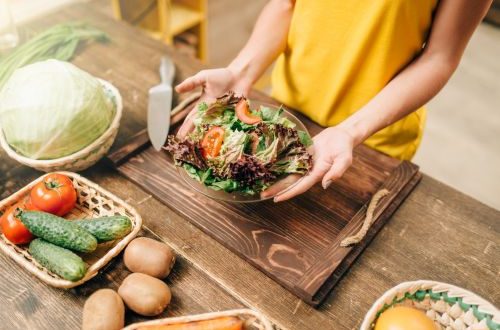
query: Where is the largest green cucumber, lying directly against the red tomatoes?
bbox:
[19,211,97,252]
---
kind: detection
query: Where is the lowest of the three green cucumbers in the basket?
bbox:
[29,238,87,282]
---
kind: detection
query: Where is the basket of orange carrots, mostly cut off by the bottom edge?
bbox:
[124,309,273,330]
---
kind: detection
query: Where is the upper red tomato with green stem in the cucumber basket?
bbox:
[30,173,76,217]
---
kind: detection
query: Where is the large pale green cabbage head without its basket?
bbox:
[0,60,115,159]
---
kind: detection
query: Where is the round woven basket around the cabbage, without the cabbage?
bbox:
[0,79,123,172]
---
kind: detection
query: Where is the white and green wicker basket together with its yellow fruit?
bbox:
[360,280,500,330]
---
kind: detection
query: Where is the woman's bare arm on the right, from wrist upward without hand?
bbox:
[339,0,491,145]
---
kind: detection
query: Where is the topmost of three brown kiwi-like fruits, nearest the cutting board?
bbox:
[123,237,175,279]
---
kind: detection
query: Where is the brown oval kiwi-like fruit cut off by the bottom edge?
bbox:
[82,289,125,330]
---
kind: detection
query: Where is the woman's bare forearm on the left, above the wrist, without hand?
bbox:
[228,0,294,87]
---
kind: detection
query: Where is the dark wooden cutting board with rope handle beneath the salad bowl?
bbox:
[109,94,421,306]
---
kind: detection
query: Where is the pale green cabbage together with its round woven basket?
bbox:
[0,60,123,172]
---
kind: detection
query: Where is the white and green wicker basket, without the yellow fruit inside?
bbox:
[360,281,500,330]
